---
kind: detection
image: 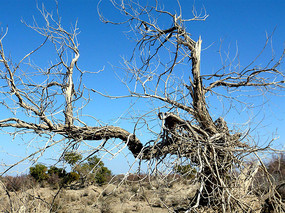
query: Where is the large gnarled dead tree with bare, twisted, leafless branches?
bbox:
[0,0,284,212]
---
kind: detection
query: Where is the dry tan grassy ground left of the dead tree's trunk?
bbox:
[0,178,199,213]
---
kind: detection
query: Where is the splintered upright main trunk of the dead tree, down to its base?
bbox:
[185,38,230,204]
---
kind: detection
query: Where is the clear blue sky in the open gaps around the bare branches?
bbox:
[0,0,285,173]
